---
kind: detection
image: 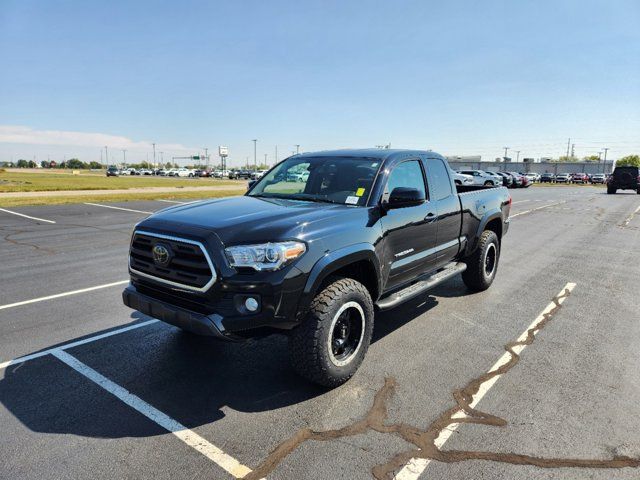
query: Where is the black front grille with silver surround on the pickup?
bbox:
[129,231,216,292]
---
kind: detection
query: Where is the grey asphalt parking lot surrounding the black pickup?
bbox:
[0,186,640,480]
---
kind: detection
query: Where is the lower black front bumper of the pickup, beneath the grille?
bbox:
[122,285,242,341]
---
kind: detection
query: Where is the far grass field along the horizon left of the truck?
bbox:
[0,171,241,192]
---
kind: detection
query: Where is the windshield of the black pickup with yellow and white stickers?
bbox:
[247,157,381,206]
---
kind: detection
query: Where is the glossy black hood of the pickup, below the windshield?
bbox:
[140,196,366,245]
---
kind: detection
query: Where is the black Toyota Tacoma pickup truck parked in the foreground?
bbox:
[123,149,511,387]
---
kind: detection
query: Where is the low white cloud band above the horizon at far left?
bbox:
[0,125,198,152]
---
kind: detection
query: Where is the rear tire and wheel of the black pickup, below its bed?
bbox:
[462,230,500,292]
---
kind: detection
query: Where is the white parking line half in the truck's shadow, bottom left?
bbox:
[51,349,251,478]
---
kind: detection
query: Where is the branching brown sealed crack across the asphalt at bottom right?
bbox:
[244,289,640,480]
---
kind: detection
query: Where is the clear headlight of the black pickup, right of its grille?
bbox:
[225,242,307,271]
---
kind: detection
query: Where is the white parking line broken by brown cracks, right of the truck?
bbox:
[394,283,576,480]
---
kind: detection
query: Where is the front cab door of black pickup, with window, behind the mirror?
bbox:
[380,159,438,290]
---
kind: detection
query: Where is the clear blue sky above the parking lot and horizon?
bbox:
[0,0,640,163]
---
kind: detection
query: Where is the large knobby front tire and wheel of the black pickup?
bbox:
[289,278,374,388]
